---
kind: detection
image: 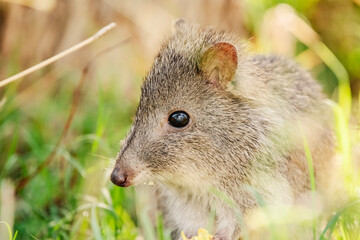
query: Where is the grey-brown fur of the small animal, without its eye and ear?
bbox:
[112,20,333,239]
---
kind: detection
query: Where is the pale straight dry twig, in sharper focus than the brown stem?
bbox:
[0,23,116,88]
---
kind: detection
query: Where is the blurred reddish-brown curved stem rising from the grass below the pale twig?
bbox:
[16,38,130,192]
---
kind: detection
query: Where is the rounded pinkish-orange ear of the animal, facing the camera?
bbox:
[199,42,238,89]
